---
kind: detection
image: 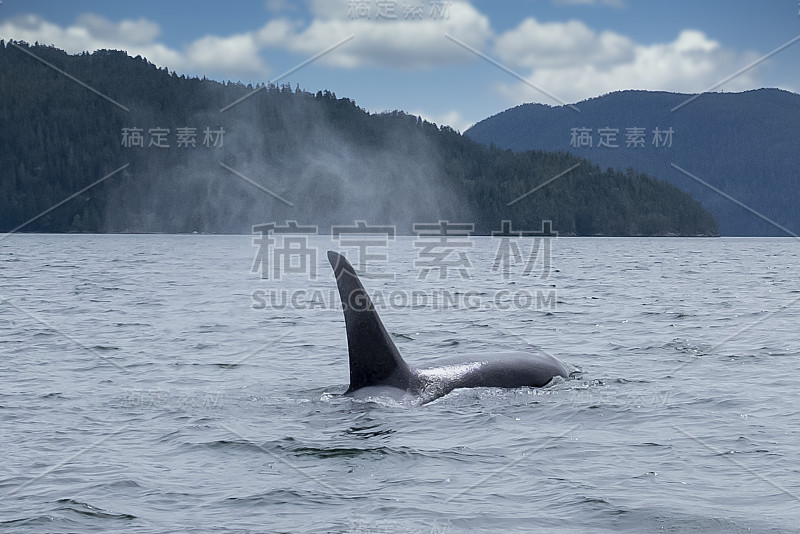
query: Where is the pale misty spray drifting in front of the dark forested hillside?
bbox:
[106,86,474,234]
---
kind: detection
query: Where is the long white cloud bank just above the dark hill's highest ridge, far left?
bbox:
[0,15,268,79]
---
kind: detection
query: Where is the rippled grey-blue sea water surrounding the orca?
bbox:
[0,235,800,533]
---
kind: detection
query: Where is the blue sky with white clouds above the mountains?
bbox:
[0,0,800,130]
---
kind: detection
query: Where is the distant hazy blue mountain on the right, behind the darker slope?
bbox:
[465,89,800,236]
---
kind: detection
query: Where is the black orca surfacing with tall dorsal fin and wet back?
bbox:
[328,251,569,404]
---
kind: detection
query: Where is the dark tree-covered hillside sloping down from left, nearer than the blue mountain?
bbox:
[0,41,716,239]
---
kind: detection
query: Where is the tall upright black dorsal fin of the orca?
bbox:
[328,250,411,393]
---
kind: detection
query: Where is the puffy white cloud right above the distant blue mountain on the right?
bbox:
[495,19,758,104]
